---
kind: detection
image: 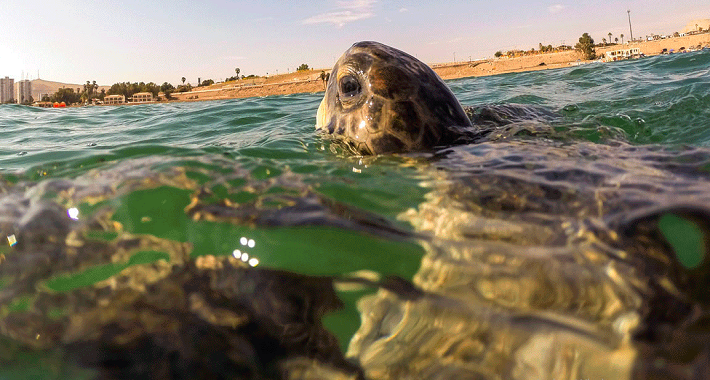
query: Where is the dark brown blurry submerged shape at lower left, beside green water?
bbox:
[0,159,358,379]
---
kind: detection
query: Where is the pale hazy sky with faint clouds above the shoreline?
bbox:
[0,0,710,85]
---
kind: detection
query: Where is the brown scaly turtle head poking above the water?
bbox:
[316,42,471,154]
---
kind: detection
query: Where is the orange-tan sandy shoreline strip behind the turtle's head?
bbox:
[173,33,710,101]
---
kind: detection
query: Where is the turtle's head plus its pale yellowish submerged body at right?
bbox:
[316,42,710,379]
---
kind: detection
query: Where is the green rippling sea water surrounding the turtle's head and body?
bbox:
[0,50,710,378]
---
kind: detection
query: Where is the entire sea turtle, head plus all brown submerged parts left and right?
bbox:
[0,43,710,379]
